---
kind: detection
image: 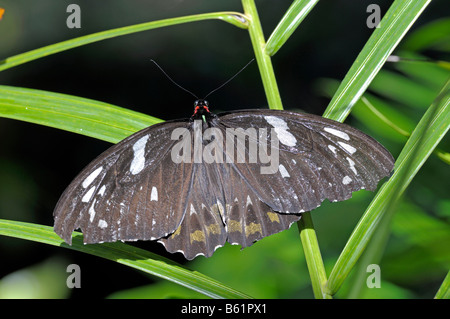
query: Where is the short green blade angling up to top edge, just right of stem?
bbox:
[265,0,319,56]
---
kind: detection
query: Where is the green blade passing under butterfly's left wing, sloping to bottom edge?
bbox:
[0,219,251,298]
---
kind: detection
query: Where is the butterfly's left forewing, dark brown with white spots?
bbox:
[54,121,193,244]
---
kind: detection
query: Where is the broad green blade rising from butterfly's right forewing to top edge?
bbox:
[324,0,431,121]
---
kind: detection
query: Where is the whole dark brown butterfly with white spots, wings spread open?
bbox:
[54,100,394,259]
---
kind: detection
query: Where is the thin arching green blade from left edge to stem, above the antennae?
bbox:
[0,12,247,71]
